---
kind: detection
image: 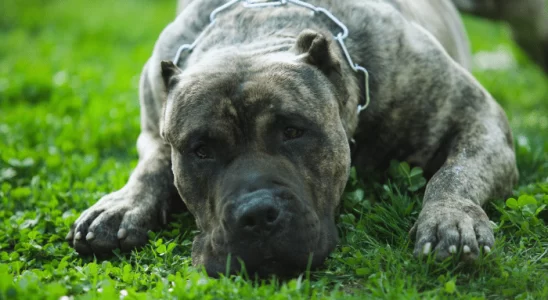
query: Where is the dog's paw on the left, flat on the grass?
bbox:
[66,189,166,255]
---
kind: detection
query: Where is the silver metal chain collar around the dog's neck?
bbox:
[173,0,371,114]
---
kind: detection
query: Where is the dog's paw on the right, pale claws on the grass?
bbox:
[410,202,495,261]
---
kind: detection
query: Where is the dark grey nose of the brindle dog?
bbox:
[236,197,281,235]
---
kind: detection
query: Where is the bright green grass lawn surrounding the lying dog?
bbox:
[0,0,548,299]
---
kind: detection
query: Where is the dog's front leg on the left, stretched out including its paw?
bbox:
[67,62,184,254]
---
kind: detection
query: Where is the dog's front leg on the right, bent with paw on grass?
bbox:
[411,99,518,260]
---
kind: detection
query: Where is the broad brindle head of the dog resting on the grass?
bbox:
[161,30,356,275]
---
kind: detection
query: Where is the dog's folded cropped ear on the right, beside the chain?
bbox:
[294,29,341,74]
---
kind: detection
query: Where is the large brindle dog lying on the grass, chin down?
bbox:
[67,0,517,275]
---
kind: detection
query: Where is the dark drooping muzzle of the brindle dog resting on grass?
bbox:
[211,168,320,275]
